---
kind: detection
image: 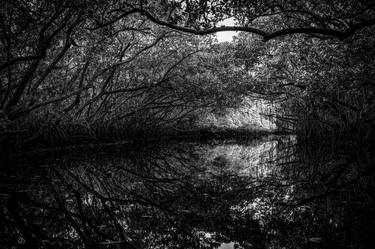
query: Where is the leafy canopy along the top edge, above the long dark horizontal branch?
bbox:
[93,0,375,40]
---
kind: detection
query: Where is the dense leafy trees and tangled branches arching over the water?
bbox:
[0,0,375,146]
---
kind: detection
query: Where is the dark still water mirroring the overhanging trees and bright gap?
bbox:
[0,137,375,248]
